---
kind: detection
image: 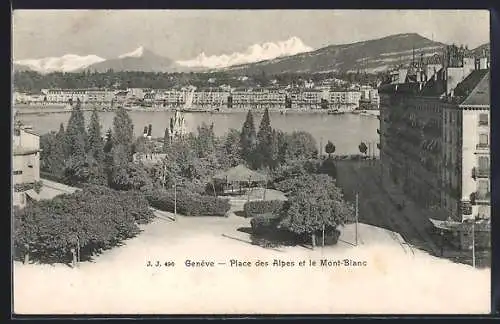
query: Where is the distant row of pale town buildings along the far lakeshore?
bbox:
[14,79,379,111]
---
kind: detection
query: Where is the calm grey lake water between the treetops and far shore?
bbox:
[19,111,379,155]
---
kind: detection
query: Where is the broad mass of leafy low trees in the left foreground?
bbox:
[14,186,154,262]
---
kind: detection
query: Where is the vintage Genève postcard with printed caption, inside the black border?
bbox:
[12,10,491,315]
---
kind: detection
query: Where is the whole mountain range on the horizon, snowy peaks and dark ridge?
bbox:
[14,33,489,75]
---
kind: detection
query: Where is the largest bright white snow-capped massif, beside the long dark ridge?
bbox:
[177,37,313,69]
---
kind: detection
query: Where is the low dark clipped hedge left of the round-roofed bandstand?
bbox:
[146,189,231,216]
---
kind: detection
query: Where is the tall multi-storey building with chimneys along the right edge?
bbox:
[378,46,491,248]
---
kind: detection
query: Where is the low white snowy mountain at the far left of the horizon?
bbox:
[14,54,105,73]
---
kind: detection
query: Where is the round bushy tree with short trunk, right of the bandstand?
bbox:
[280,175,354,247]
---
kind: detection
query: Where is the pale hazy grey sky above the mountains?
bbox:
[13,10,490,60]
